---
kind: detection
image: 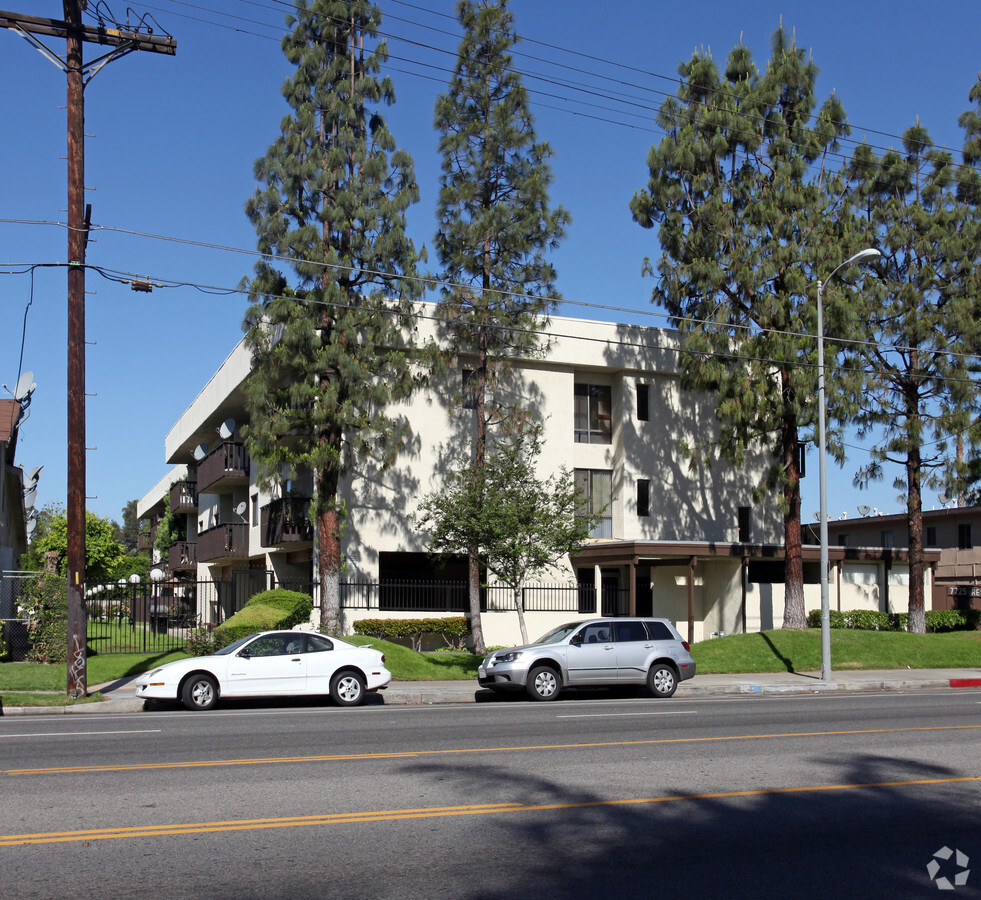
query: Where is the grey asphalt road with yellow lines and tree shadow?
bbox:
[0,690,981,900]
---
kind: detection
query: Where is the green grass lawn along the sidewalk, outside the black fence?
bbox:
[0,629,981,706]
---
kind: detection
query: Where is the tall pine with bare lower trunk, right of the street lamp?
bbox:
[839,123,981,634]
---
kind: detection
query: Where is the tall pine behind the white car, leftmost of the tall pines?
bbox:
[244,0,420,631]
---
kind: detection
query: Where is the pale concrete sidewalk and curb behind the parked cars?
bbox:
[0,669,981,716]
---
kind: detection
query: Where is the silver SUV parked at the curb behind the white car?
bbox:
[477,618,695,700]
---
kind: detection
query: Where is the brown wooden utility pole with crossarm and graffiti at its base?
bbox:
[0,0,177,699]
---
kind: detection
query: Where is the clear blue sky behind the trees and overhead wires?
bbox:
[0,0,981,522]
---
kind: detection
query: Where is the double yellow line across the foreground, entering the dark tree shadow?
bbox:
[0,775,981,847]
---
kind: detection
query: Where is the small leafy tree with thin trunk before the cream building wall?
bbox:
[418,425,598,644]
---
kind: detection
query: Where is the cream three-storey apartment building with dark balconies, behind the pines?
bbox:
[138,317,904,644]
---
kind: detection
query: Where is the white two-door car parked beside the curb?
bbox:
[135,631,392,709]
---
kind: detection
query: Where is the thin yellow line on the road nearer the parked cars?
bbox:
[0,725,981,775]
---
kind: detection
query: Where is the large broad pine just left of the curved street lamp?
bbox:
[630,26,851,628]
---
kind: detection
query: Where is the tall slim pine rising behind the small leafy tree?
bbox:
[435,0,570,653]
